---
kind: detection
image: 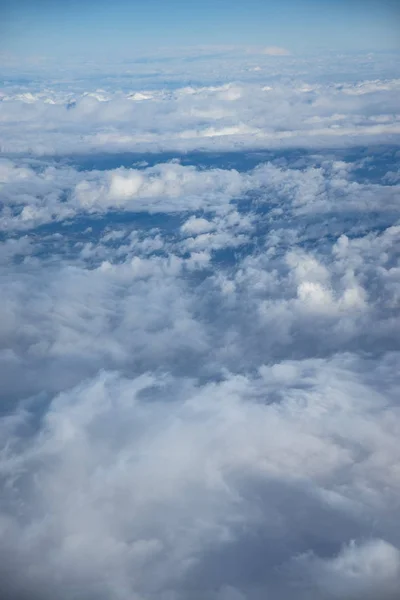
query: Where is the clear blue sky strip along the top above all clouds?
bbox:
[0,0,400,57]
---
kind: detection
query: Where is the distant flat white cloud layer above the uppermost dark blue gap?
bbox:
[0,67,400,156]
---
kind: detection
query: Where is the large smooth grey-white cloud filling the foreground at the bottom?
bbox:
[1,356,400,598]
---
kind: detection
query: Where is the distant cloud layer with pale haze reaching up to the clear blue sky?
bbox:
[0,54,400,156]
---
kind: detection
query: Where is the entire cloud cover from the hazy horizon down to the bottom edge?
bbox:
[0,48,400,600]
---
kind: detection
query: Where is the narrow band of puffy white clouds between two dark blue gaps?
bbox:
[0,155,399,234]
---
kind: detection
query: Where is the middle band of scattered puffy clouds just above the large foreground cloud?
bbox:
[0,206,400,398]
